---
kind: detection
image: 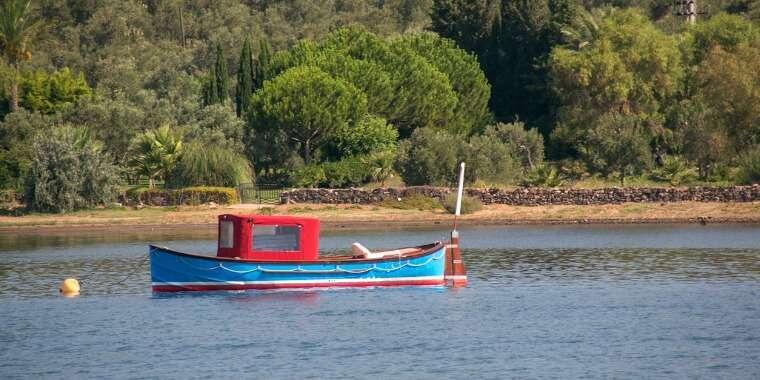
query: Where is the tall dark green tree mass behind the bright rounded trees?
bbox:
[431,0,576,135]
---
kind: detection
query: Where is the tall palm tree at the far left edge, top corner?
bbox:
[0,0,40,112]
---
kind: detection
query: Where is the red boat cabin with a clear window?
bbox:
[216,214,319,261]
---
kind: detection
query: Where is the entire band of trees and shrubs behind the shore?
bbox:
[0,0,760,211]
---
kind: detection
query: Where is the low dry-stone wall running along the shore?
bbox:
[280,184,760,206]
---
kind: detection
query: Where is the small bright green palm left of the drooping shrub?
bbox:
[129,126,182,189]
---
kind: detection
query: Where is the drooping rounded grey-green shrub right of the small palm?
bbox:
[171,142,253,187]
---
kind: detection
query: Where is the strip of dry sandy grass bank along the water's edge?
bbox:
[0,202,760,233]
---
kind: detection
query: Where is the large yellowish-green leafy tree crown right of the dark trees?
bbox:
[549,10,682,144]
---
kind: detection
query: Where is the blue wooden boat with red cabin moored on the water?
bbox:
[150,215,466,292]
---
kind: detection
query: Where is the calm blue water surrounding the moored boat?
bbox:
[0,225,760,379]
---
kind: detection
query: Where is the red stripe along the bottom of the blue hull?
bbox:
[153,280,446,292]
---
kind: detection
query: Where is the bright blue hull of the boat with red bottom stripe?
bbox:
[150,243,446,292]
